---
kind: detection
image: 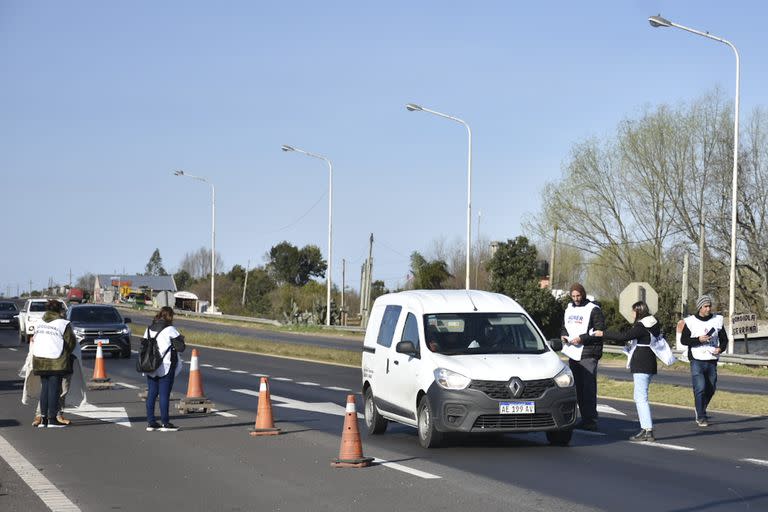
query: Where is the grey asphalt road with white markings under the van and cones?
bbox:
[0,332,768,512]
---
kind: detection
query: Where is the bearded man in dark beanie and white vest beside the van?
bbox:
[560,283,605,431]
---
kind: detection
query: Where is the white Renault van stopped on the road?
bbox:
[362,290,576,448]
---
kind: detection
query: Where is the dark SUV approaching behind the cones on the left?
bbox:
[67,304,131,358]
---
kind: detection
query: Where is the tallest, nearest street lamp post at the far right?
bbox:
[648,15,739,354]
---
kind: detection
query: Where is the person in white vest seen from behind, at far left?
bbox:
[30,300,77,428]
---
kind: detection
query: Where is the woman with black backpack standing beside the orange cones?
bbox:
[144,306,184,432]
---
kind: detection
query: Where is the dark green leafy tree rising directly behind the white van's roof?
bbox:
[488,236,563,337]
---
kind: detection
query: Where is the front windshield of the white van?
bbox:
[424,313,548,355]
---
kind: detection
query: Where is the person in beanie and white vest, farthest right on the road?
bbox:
[680,295,728,427]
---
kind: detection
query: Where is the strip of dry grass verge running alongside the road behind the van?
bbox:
[131,325,768,416]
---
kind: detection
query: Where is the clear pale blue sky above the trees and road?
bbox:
[0,0,768,295]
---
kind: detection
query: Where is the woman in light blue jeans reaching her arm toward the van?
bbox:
[595,301,661,441]
